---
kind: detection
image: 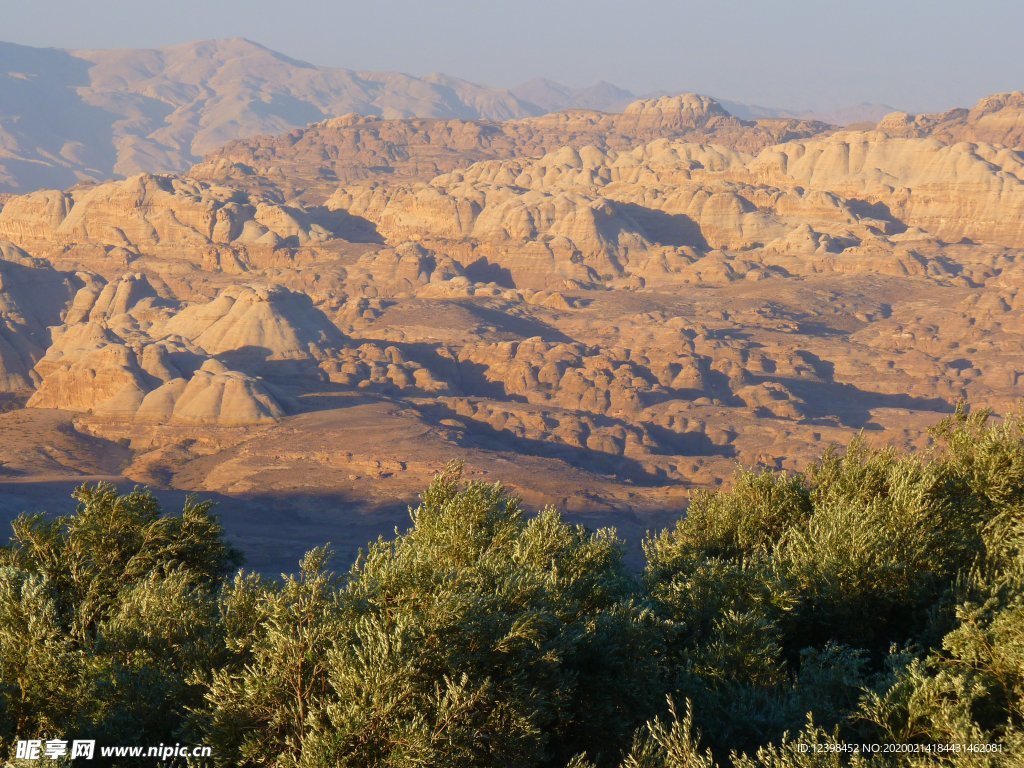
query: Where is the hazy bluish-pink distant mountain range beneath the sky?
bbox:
[0,39,892,193]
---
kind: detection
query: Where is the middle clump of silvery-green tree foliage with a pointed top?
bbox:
[208,466,654,766]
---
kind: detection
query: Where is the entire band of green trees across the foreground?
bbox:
[0,412,1024,768]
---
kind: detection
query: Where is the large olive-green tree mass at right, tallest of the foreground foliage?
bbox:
[634,410,1024,765]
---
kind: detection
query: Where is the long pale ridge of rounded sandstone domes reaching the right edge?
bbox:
[327,132,1024,288]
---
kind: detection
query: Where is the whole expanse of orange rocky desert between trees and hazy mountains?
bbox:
[0,93,1024,568]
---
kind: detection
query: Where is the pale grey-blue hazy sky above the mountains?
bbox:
[0,0,1024,111]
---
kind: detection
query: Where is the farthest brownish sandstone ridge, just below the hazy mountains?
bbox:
[189,93,828,203]
